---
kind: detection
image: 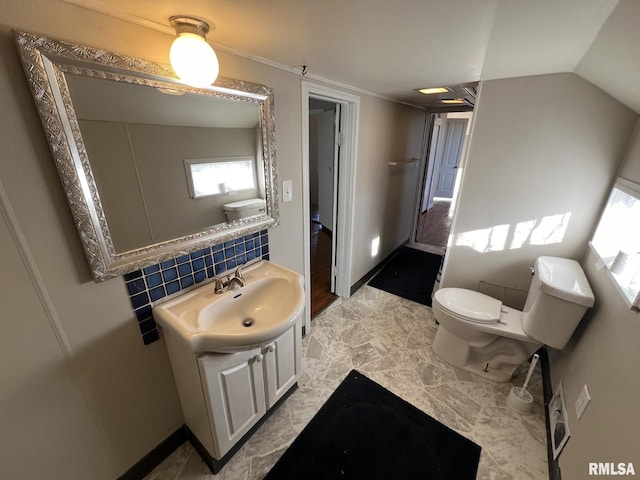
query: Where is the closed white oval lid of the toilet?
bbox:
[434,288,502,323]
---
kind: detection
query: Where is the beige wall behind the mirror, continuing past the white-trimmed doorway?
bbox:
[0,0,430,479]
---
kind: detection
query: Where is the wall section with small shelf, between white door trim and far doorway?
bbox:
[351,97,426,285]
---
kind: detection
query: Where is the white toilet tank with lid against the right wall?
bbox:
[522,257,595,349]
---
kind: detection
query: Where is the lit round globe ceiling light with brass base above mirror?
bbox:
[169,16,220,87]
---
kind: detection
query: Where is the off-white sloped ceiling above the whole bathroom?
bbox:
[62,0,640,112]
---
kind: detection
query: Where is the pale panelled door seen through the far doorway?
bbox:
[434,118,467,198]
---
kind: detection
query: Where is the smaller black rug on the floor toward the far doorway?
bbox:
[369,247,442,306]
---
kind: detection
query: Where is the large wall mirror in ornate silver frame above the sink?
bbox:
[13,32,279,281]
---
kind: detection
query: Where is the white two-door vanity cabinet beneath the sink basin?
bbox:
[167,318,302,469]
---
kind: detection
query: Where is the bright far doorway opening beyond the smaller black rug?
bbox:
[413,112,473,255]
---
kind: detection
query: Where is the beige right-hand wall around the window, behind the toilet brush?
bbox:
[551,121,640,478]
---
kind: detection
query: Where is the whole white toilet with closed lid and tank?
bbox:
[432,257,594,382]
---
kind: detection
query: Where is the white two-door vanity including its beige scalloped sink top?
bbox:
[153,260,304,473]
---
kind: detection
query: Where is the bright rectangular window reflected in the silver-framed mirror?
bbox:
[184,157,256,198]
